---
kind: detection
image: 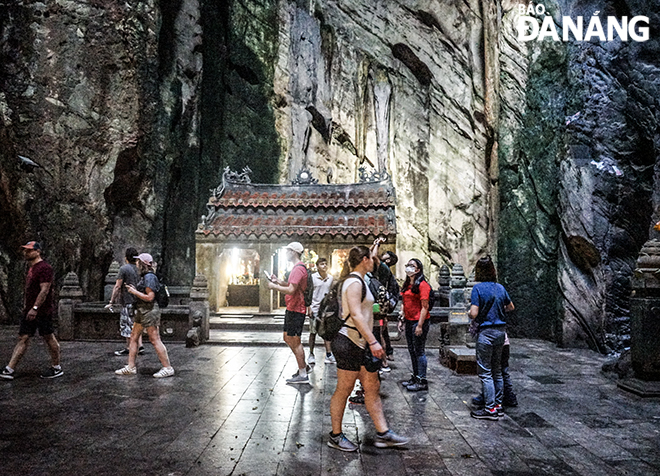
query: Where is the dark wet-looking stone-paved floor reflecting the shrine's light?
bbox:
[0,328,660,476]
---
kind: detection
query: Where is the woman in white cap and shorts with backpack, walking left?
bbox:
[115,253,174,378]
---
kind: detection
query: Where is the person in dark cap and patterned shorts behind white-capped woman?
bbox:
[105,248,144,355]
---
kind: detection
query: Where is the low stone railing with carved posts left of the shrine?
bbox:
[58,268,210,343]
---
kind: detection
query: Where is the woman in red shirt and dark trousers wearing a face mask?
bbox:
[399,258,431,392]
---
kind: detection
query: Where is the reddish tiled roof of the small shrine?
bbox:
[197,182,396,238]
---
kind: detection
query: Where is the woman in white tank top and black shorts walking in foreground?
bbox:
[328,240,408,451]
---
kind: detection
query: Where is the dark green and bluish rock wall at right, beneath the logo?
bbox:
[499,1,659,352]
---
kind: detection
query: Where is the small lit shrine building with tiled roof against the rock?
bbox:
[195,168,396,313]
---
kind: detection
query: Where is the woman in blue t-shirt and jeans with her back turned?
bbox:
[469,256,514,420]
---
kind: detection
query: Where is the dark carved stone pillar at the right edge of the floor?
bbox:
[618,240,660,397]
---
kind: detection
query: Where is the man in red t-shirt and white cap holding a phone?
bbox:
[268,241,311,384]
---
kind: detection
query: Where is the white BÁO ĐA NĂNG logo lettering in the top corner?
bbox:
[517,3,649,41]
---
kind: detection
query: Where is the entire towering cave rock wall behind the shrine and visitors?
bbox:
[0,0,659,351]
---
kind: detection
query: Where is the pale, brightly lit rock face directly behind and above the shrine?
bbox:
[274,0,494,281]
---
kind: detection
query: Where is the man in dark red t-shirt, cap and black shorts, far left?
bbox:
[0,241,64,380]
